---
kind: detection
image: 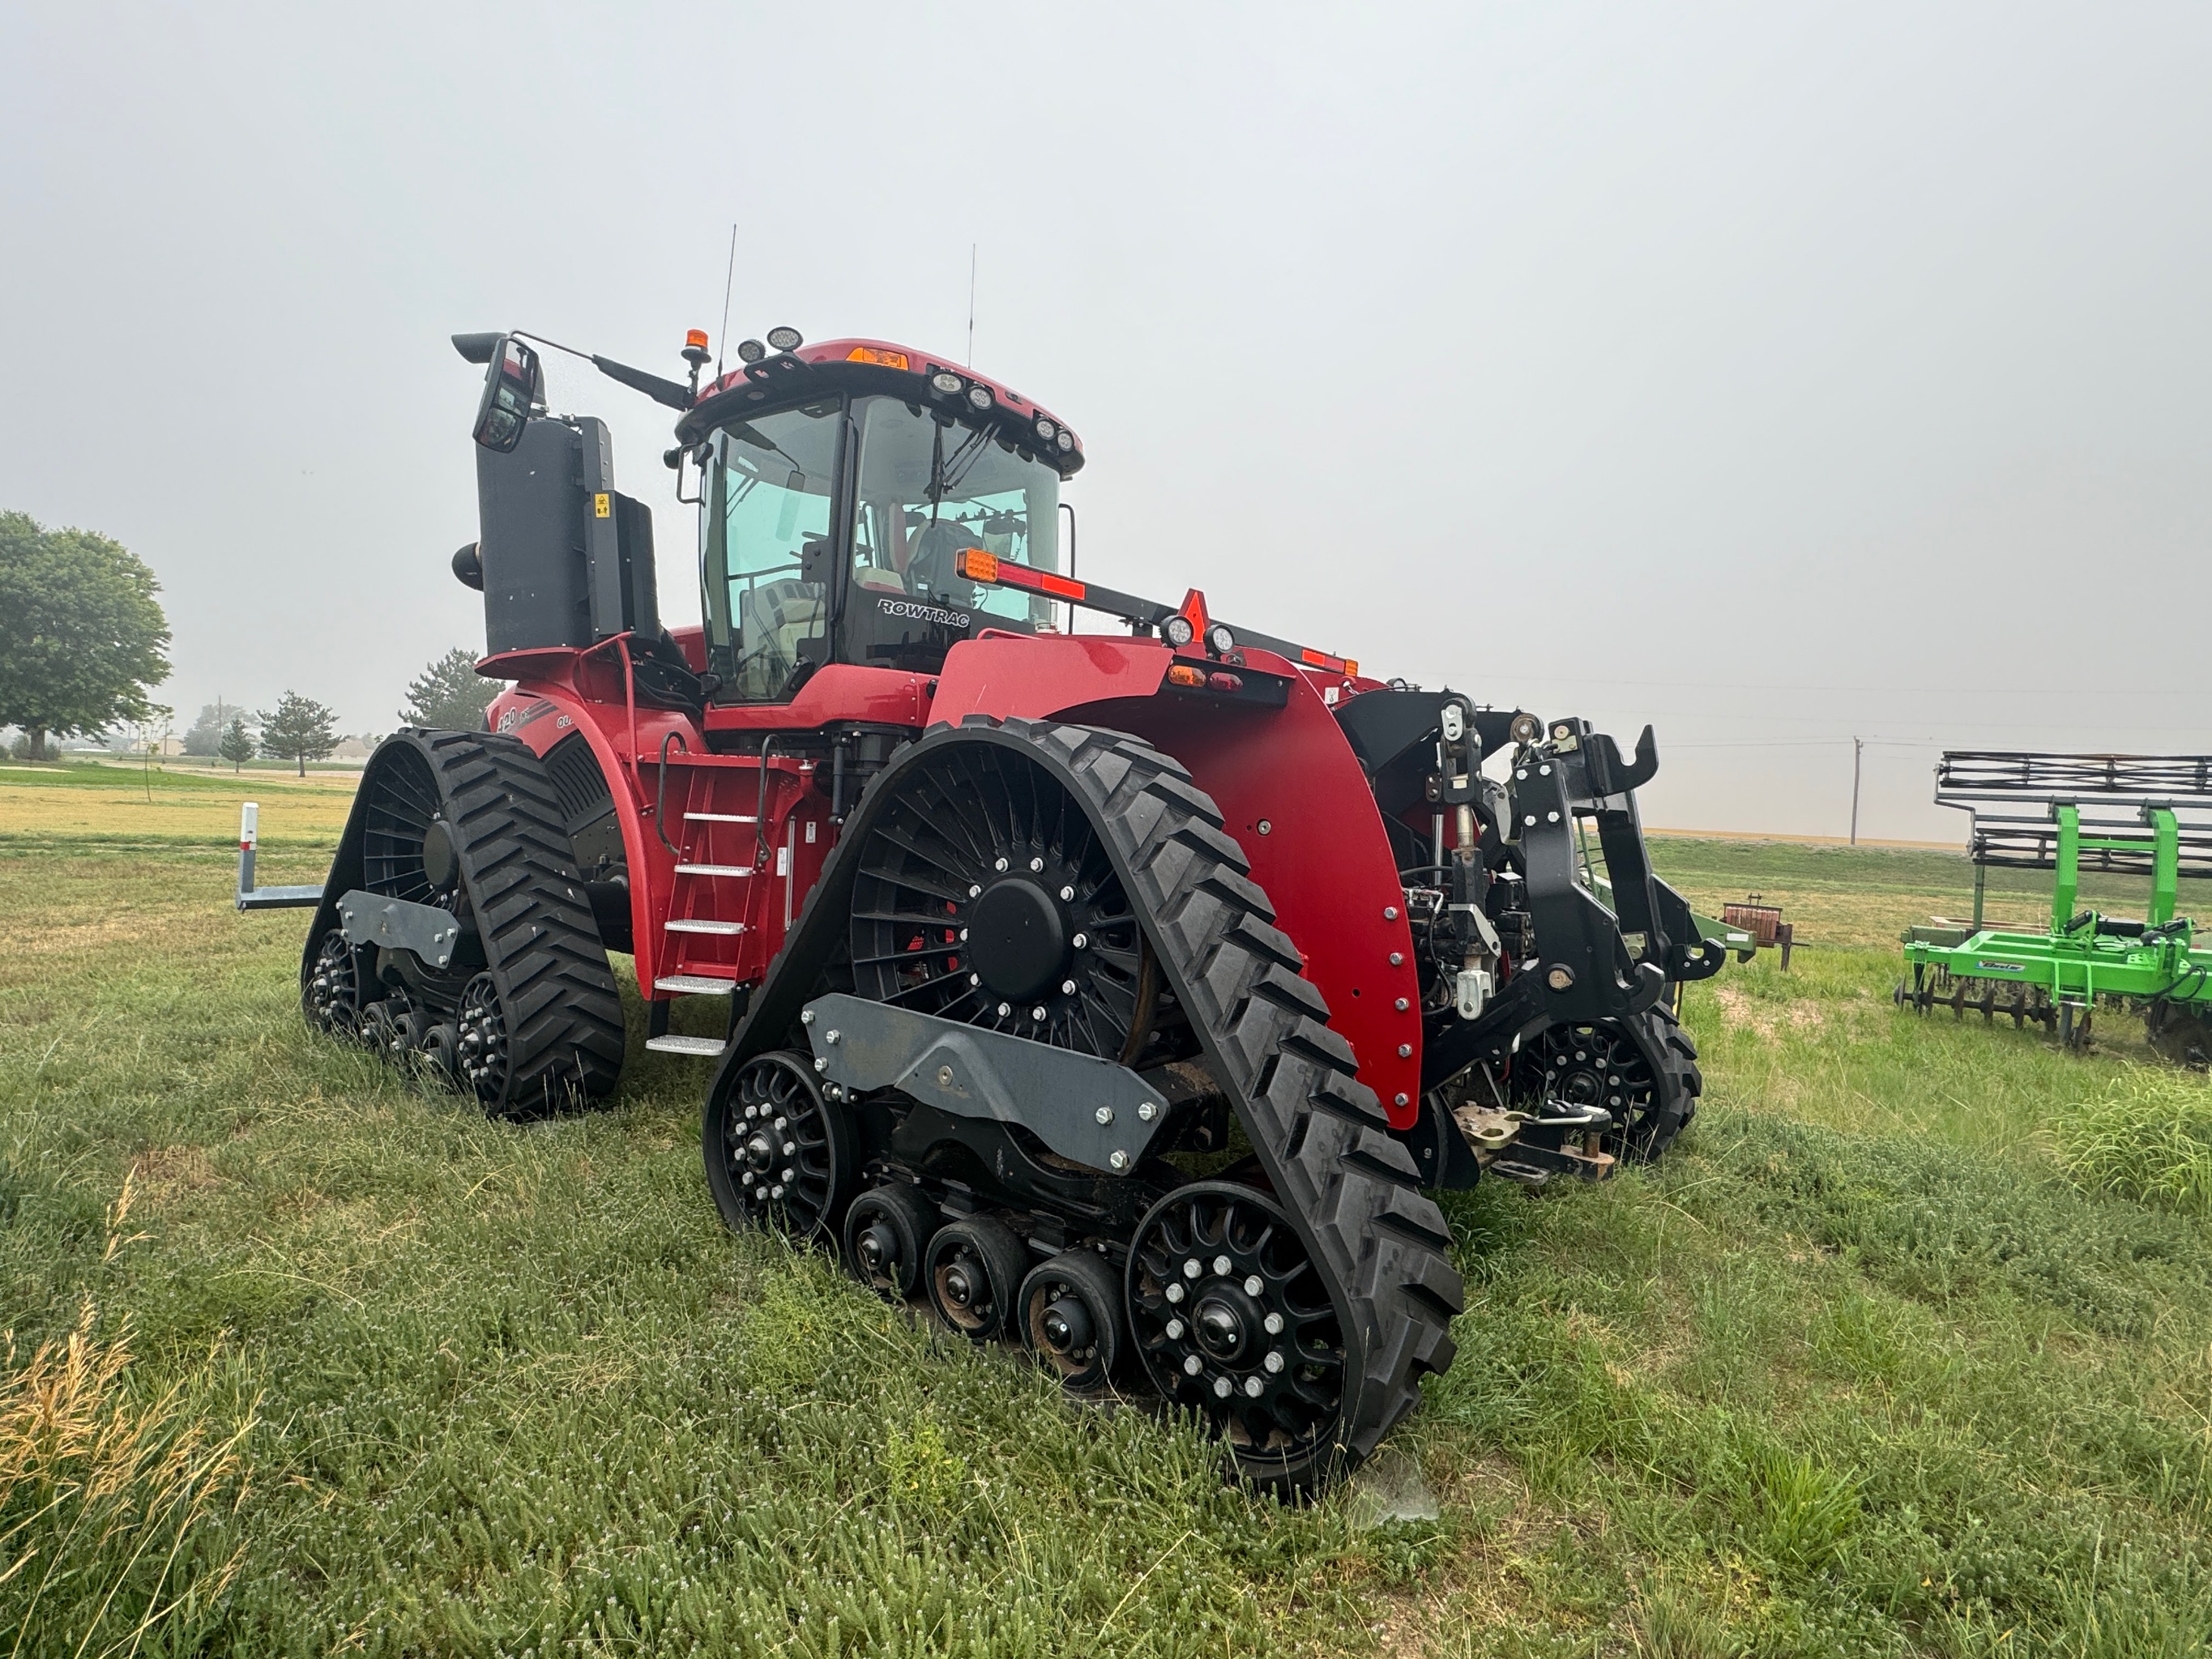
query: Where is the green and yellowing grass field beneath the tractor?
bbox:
[0,768,2212,1659]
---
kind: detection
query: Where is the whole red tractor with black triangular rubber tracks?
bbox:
[241,330,1721,1491]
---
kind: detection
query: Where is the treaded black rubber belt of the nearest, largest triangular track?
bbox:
[717,714,1463,1484]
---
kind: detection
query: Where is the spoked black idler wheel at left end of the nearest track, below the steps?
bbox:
[708,1048,854,1243]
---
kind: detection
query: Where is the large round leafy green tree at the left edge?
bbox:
[0,514,168,761]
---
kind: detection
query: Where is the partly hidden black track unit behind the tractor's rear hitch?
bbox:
[1513,1009,1706,1163]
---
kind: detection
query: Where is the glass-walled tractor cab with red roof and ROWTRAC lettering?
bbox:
[677,341,1082,703]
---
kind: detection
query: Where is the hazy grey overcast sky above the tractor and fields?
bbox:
[0,0,2212,838]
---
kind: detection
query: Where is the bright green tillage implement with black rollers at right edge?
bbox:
[1898,752,2212,1066]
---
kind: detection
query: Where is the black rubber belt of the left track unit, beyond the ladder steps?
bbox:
[310,730,624,1117]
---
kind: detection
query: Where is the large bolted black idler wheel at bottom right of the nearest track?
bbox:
[1128,1181,1345,1491]
